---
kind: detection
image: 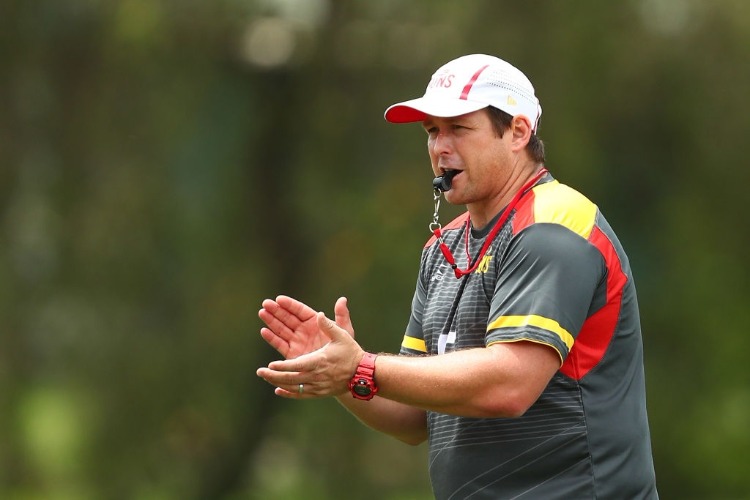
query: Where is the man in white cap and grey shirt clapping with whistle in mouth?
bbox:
[258,54,657,499]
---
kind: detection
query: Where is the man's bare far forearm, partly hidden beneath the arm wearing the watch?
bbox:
[336,392,427,445]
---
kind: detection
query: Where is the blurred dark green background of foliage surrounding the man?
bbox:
[0,0,750,500]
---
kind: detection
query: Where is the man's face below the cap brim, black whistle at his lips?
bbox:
[422,109,512,207]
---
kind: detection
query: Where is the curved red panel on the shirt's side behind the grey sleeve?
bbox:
[560,227,628,380]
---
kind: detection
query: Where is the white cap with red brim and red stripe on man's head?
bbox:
[385,54,542,131]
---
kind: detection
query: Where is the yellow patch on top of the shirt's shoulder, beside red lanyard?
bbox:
[534,181,597,239]
